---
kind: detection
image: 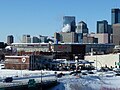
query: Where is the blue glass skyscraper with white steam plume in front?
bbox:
[63,16,76,32]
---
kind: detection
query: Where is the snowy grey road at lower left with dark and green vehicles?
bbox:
[0,74,56,88]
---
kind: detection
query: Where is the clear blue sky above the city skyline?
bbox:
[0,0,120,42]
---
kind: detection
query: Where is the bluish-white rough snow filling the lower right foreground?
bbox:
[53,76,120,90]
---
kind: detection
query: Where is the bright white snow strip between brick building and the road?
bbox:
[0,69,69,78]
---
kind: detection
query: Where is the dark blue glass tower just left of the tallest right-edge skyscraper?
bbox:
[97,20,108,33]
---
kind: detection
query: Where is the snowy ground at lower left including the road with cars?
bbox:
[0,69,68,88]
